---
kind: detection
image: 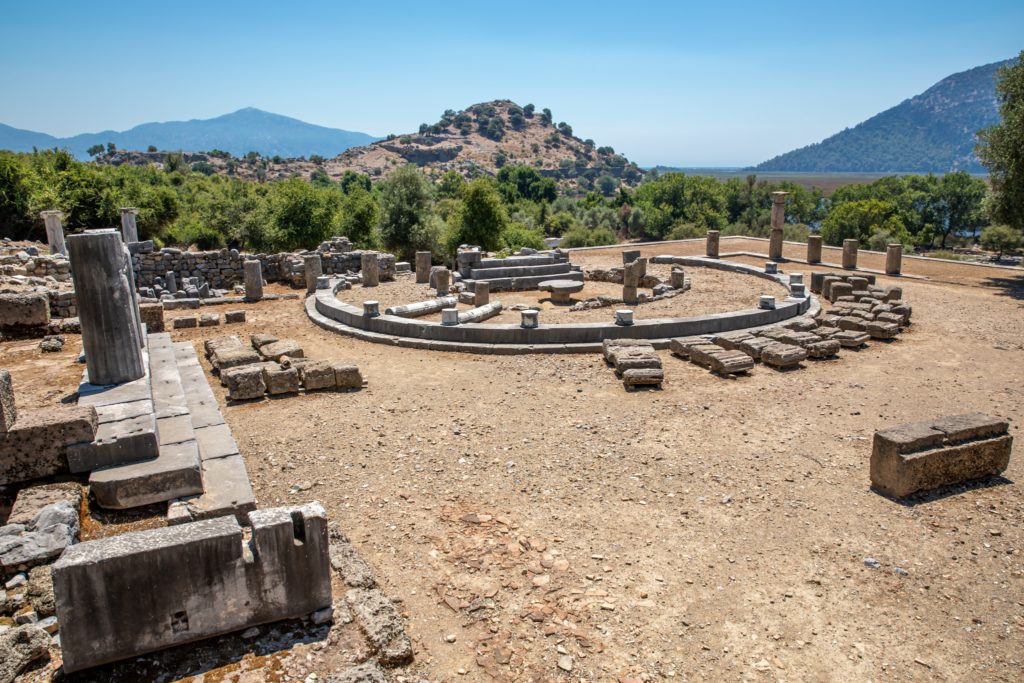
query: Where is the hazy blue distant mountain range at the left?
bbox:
[0,108,381,159]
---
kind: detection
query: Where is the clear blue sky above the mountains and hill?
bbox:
[0,0,1024,166]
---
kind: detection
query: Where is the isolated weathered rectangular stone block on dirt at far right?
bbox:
[870,413,1013,499]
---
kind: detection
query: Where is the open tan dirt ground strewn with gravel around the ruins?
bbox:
[0,250,1024,683]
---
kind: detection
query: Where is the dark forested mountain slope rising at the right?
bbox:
[749,59,1016,173]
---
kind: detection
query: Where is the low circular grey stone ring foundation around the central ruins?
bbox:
[306,257,821,355]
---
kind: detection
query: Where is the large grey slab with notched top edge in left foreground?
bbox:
[53,504,329,673]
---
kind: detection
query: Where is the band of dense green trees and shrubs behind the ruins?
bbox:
[0,144,1003,261]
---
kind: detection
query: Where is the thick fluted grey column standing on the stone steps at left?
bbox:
[68,229,145,384]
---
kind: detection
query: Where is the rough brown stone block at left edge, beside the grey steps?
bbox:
[0,405,99,485]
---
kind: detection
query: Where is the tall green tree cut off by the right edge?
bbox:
[975,50,1024,230]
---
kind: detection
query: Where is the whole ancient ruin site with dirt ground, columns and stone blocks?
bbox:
[0,202,1024,683]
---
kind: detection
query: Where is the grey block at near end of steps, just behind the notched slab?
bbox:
[89,441,203,510]
